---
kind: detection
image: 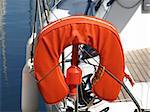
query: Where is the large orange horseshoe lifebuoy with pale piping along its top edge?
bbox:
[34,16,125,104]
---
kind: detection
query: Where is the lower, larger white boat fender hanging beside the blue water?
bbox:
[21,60,39,112]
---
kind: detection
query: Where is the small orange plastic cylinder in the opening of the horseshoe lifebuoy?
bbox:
[66,65,82,85]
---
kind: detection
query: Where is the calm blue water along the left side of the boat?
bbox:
[0,0,33,112]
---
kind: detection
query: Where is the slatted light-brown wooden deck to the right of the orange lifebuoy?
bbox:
[118,48,150,101]
